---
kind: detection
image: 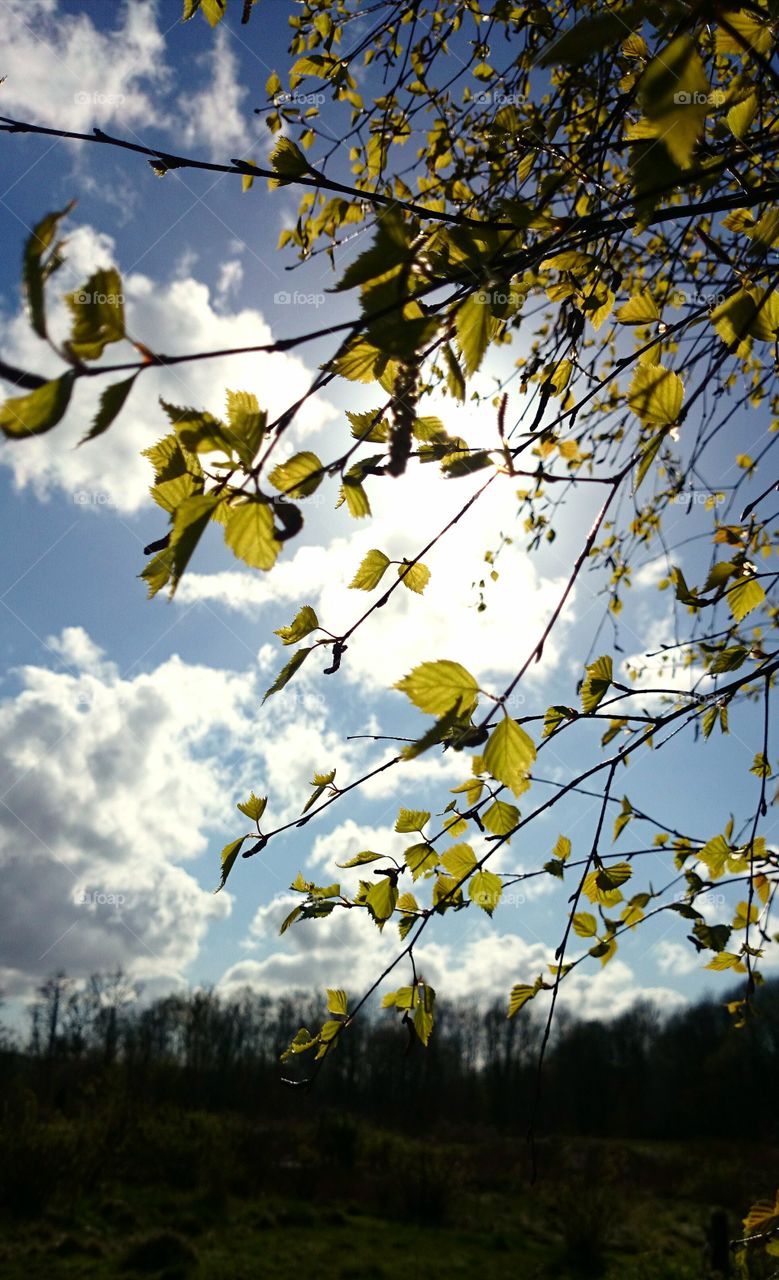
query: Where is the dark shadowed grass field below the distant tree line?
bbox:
[0,1112,779,1280]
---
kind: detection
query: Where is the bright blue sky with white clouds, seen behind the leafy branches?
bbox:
[0,0,773,1015]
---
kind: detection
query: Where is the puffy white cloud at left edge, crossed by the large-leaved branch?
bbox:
[0,227,334,512]
